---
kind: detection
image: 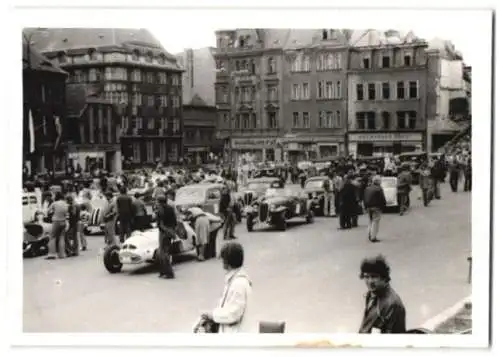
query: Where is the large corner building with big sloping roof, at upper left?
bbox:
[28,28,183,169]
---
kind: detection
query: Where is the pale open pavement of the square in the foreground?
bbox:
[23,186,471,333]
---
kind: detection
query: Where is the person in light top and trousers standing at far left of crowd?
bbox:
[46,191,69,260]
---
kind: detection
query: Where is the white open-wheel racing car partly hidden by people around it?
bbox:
[103,212,222,273]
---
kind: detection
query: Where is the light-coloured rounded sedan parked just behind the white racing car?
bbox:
[175,183,224,214]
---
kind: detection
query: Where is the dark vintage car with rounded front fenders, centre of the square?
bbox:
[246,187,314,232]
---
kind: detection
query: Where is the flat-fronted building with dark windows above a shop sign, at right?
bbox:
[348,31,428,156]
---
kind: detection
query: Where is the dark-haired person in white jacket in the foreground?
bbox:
[197,242,253,333]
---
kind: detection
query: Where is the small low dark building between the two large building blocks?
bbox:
[183,94,221,165]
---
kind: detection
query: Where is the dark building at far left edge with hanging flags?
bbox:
[23,34,68,173]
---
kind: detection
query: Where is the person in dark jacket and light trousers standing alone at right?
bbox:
[363,175,386,243]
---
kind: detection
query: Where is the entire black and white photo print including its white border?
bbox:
[2,0,493,347]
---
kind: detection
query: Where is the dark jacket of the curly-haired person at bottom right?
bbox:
[359,285,406,333]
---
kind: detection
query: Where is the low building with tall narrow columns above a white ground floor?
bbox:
[66,85,122,172]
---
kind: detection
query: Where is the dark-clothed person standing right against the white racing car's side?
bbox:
[157,196,177,279]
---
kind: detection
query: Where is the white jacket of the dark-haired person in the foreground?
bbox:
[212,268,257,333]
